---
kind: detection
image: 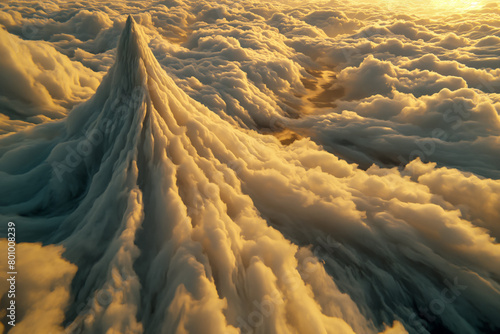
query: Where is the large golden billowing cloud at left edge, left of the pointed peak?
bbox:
[0,25,102,132]
